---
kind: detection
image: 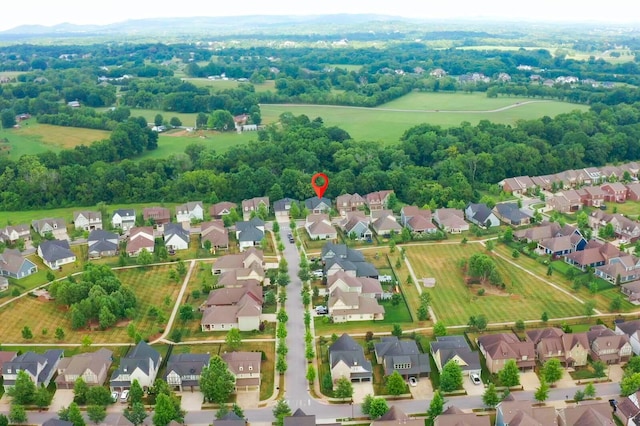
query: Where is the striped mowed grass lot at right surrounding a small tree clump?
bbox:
[405,244,584,325]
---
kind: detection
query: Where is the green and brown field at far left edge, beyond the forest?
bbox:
[0,119,110,159]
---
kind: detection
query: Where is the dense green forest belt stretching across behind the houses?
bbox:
[0,103,640,210]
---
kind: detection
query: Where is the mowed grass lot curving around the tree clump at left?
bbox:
[0,266,180,344]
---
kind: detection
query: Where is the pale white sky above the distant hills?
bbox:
[0,0,640,31]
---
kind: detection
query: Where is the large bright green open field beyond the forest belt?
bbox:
[261,93,588,144]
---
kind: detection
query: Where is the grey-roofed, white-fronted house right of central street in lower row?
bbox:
[329,333,373,382]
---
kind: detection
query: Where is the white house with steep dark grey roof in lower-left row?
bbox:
[109,340,162,392]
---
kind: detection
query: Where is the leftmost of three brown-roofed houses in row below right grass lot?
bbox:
[477,333,536,374]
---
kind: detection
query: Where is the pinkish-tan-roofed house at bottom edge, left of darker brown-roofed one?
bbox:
[496,397,558,426]
